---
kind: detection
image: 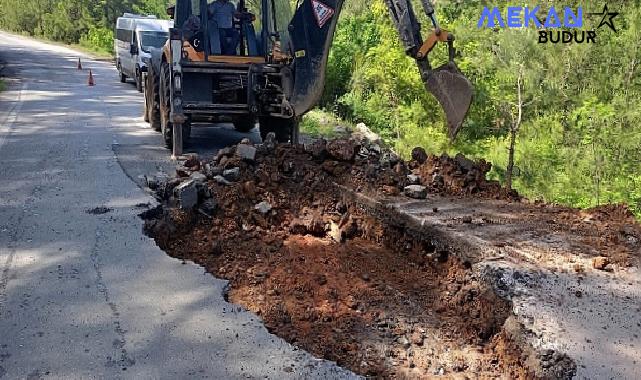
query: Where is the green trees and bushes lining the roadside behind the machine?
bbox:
[0,0,641,216]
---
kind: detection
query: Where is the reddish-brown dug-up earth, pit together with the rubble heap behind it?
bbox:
[140,138,584,378]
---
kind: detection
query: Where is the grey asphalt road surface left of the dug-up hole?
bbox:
[0,33,352,379]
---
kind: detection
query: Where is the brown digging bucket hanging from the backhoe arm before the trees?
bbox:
[425,62,473,140]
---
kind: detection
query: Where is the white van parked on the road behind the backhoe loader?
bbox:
[114,13,174,92]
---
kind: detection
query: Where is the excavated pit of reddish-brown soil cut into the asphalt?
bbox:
[144,199,532,378]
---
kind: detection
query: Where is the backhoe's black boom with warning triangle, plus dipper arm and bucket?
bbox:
[289,0,473,139]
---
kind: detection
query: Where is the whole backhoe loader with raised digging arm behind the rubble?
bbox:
[145,0,473,156]
